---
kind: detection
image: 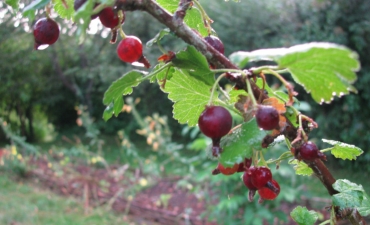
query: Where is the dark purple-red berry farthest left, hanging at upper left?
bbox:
[33,17,59,50]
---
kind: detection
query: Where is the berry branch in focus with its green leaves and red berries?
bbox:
[7,0,370,225]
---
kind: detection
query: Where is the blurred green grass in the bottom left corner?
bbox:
[0,174,128,225]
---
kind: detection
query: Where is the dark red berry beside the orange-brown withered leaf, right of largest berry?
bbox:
[256,105,279,130]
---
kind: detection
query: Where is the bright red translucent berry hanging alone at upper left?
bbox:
[117,36,143,63]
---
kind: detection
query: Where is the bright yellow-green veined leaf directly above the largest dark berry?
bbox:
[164,69,216,126]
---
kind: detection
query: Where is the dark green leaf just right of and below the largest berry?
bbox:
[219,118,268,166]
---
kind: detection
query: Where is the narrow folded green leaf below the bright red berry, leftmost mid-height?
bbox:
[103,70,145,119]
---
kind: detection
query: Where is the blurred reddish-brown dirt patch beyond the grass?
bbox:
[22,156,356,225]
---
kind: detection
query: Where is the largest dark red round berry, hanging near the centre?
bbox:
[198,106,233,138]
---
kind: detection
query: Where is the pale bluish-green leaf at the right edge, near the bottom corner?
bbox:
[332,179,370,216]
